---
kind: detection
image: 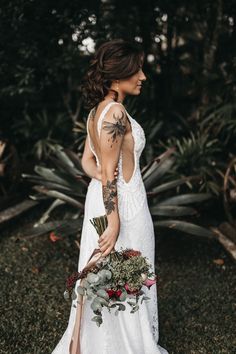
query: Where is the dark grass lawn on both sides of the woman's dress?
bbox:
[0,208,236,354]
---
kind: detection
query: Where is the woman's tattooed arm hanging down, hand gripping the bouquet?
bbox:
[99,104,127,256]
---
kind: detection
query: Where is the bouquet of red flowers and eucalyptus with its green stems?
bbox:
[64,215,157,327]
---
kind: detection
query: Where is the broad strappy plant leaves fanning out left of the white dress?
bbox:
[22,145,89,241]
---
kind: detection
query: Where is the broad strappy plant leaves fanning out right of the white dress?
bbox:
[142,148,213,238]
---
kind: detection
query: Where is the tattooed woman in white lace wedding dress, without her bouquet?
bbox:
[52,39,168,354]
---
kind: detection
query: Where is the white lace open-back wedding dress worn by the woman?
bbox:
[52,101,168,354]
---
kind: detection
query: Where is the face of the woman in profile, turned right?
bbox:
[119,67,146,95]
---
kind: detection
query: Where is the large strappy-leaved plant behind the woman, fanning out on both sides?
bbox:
[23,146,215,242]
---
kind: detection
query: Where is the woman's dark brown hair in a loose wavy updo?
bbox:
[81,39,144,109]
